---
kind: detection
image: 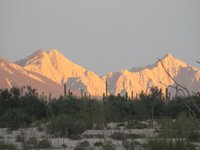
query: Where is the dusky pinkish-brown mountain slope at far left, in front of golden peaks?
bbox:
[0,56,62,97]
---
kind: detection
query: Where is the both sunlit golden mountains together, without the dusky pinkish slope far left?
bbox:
[1,49,200,97]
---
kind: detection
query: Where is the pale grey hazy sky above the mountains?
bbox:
[0,0,200,75]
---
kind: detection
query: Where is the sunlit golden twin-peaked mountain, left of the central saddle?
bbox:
[15,49,105,96]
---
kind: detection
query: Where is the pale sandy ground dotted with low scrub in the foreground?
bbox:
[0,123,200,150]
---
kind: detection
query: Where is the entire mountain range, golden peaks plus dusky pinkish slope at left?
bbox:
[0,49,200,97]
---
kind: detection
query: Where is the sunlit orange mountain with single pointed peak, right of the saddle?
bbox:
[104,54,200,96]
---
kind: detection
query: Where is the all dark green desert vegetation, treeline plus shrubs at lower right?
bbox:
[0,87,200,150]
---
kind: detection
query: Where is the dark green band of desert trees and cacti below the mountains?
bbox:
[0,87,200,136]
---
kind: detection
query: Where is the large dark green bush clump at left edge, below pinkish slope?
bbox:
[0,87,47,129]
